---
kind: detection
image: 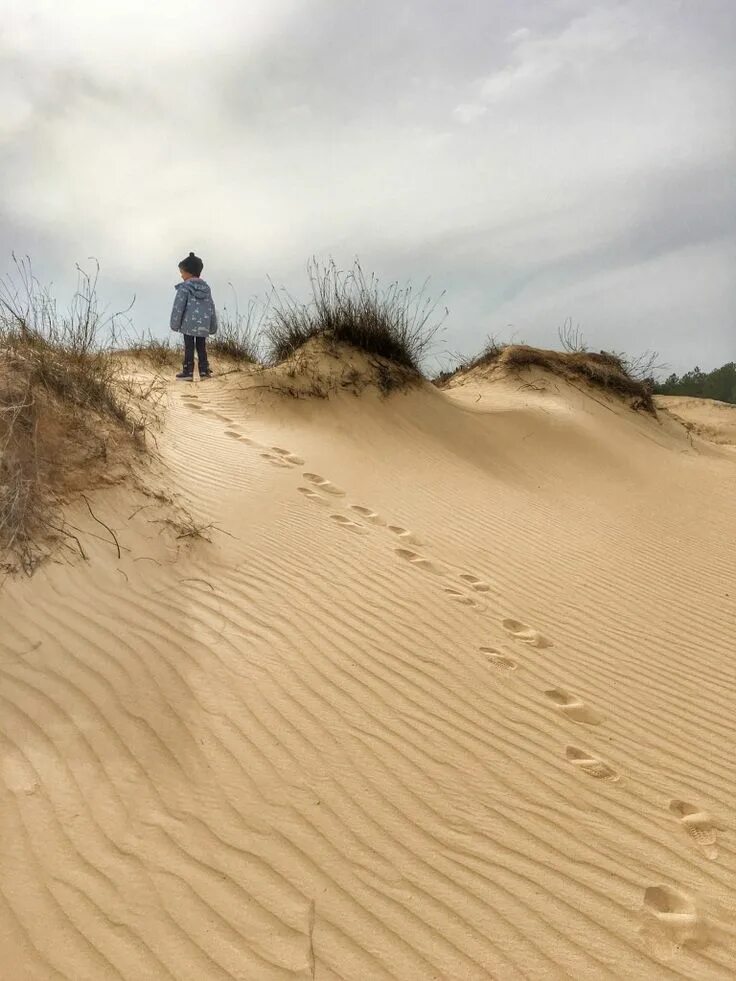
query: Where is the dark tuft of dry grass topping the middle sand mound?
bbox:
[264,262,448,385]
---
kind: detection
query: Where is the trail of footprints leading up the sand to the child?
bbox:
[182,386,718,958]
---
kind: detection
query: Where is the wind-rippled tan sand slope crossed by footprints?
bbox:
[0,362,736,981]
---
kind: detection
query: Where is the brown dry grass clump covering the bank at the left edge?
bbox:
[0,259,154,573]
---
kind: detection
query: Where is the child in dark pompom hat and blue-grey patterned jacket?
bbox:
[171,252,217,381]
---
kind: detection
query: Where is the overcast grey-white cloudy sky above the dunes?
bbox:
[0,0,736,370]
